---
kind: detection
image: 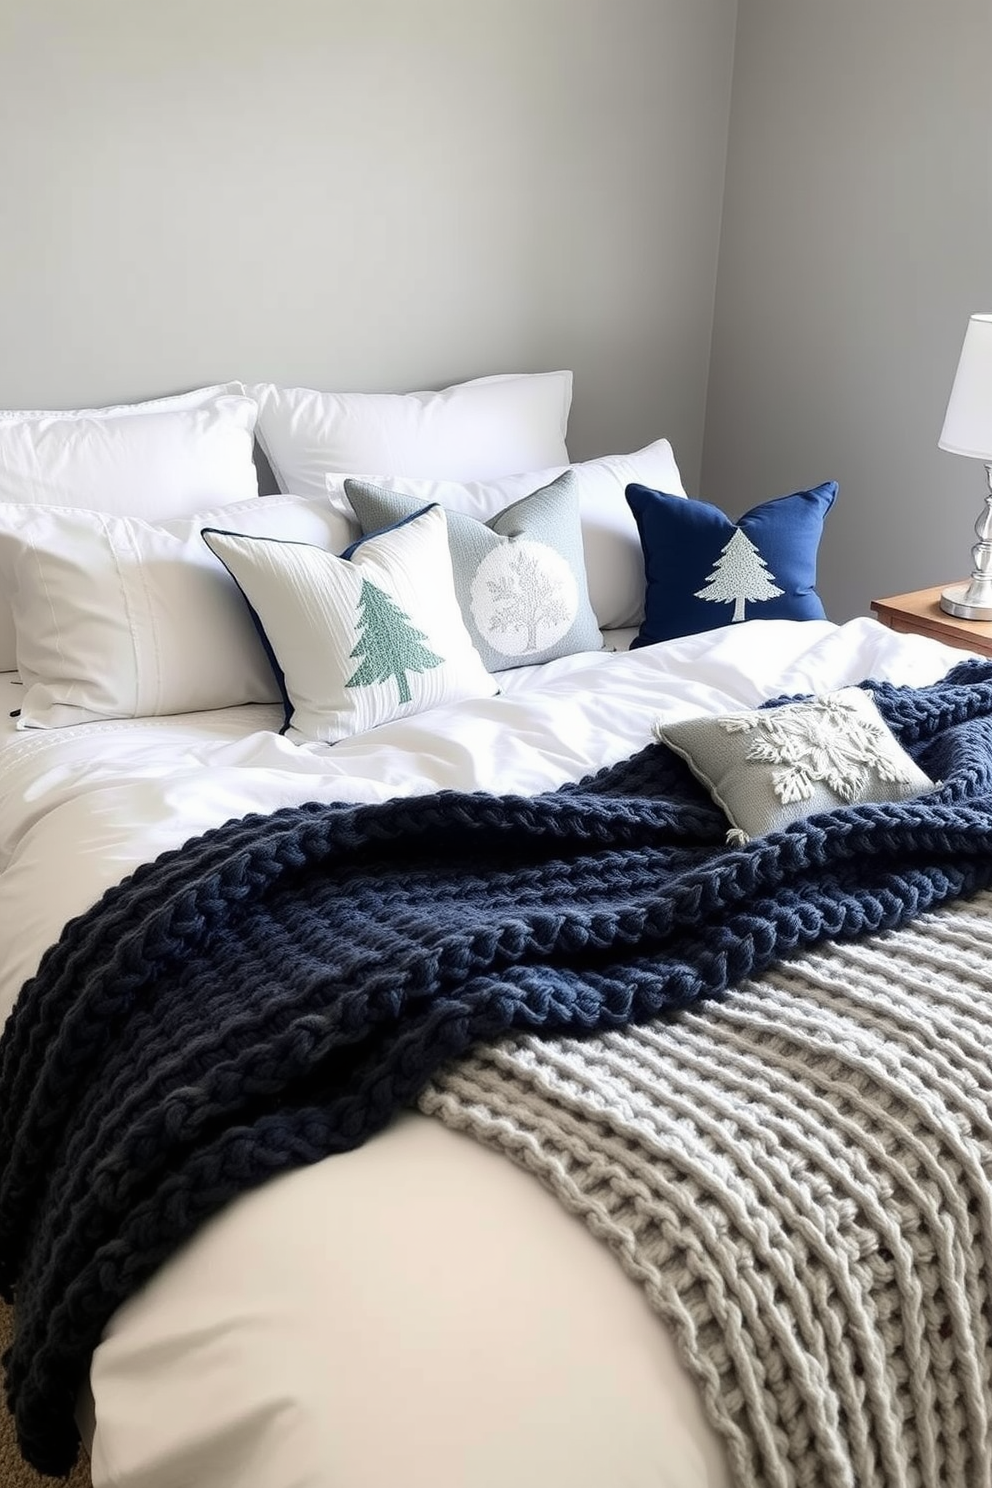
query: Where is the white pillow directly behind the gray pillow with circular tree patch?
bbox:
[324,439,686,631]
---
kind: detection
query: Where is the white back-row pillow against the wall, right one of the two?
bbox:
[247,372,571,496]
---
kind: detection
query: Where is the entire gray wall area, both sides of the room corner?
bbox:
[0,0,992,619]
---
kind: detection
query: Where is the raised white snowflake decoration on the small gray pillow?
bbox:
[720,698,912,805]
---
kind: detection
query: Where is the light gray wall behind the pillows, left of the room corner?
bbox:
[0,0,736,484]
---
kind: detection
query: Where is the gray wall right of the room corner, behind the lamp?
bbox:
[699,0,992,619]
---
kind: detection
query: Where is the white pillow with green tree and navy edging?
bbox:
[204,506,497,744]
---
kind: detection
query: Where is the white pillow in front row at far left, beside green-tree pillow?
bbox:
[0,496,352,728]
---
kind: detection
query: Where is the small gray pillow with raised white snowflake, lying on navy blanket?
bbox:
[654,687,934,841]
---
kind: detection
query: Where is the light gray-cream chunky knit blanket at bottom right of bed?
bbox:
[419,893,992,1488]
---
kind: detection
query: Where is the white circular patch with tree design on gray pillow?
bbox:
[470,540,579,656]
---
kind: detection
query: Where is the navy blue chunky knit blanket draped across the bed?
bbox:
[0,662,992,1473]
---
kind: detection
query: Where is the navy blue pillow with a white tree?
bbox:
[626,481,837,647]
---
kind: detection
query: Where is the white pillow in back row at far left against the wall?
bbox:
[0,382,259,671]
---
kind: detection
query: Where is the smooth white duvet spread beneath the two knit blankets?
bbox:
[0,620,962,1488]
